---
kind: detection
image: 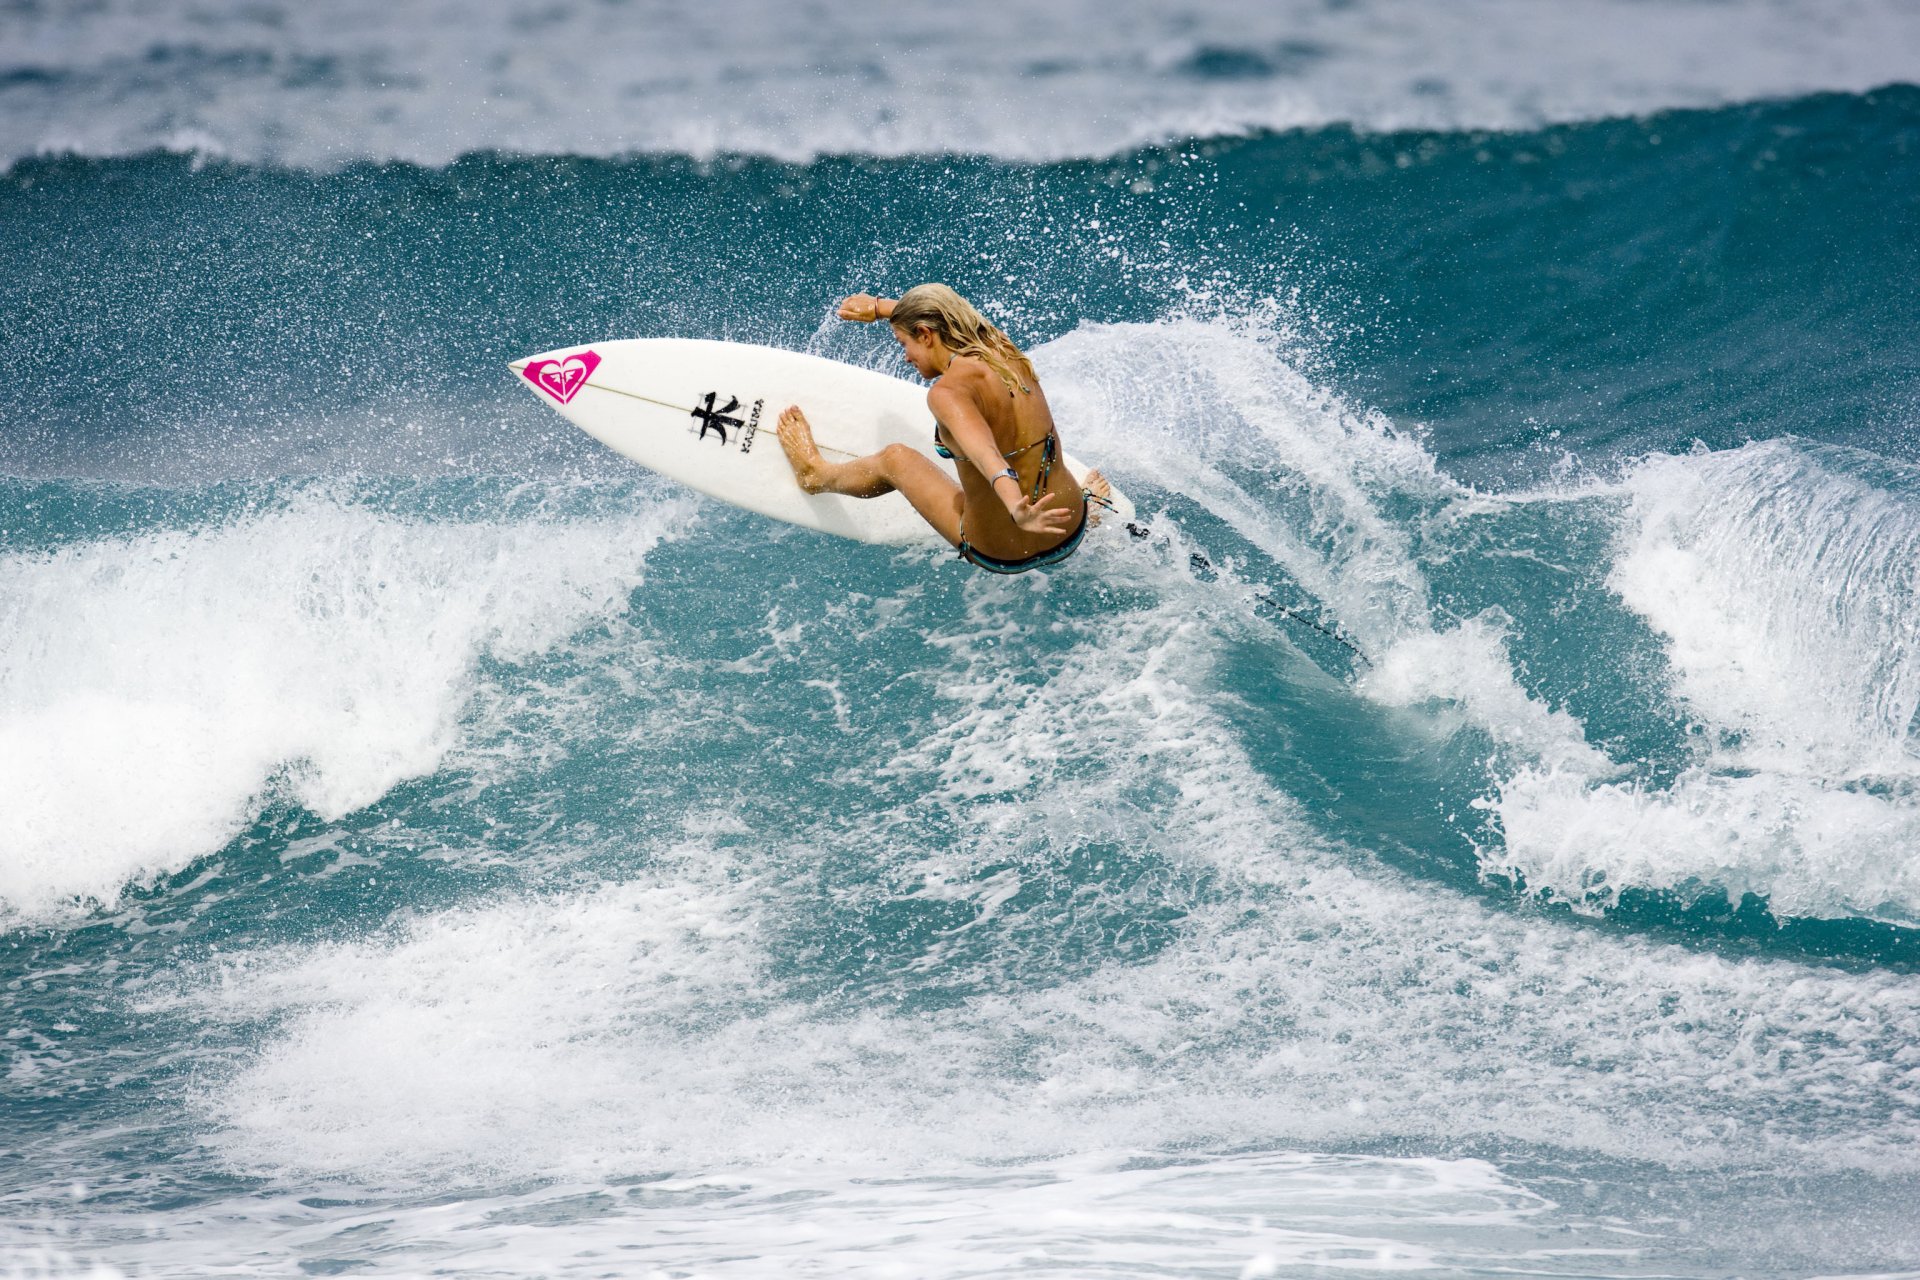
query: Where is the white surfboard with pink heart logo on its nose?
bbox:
[513,338,1133,545]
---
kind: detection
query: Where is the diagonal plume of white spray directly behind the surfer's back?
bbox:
[1035,309,1613,775]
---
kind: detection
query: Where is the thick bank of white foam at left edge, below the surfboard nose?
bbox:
[0,483,687,913]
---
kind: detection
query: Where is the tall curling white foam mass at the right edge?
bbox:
[1490,441,1920,925]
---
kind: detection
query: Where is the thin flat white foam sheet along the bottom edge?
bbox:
[0,1151,1574,1280]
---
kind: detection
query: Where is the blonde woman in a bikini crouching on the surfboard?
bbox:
[780,284,1110,574]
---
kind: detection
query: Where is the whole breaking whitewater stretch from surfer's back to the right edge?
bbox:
[1039,317,1920,927]
